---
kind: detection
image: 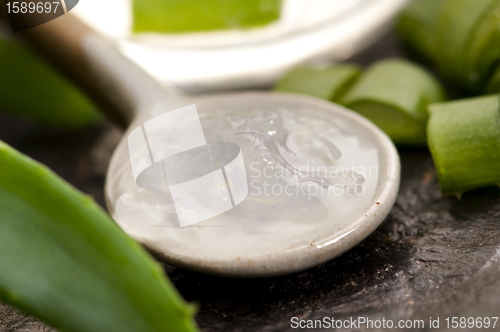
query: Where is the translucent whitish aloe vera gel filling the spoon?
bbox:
[108,98,379,260]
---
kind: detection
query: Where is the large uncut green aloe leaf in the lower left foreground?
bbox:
[0,142,197,332]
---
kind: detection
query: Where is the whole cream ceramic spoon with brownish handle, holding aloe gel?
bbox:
[6,14,400,277]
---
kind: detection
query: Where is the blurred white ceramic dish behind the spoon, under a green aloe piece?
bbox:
[73,0,409,93]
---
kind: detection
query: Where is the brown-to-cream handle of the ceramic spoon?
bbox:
[0,10,168,127]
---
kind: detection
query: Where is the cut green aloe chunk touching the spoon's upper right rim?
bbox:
[341,59,446,146]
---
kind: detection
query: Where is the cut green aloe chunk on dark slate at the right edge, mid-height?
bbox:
[427,95,500,196]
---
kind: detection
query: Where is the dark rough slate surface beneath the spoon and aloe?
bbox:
[0,31,500,332]
